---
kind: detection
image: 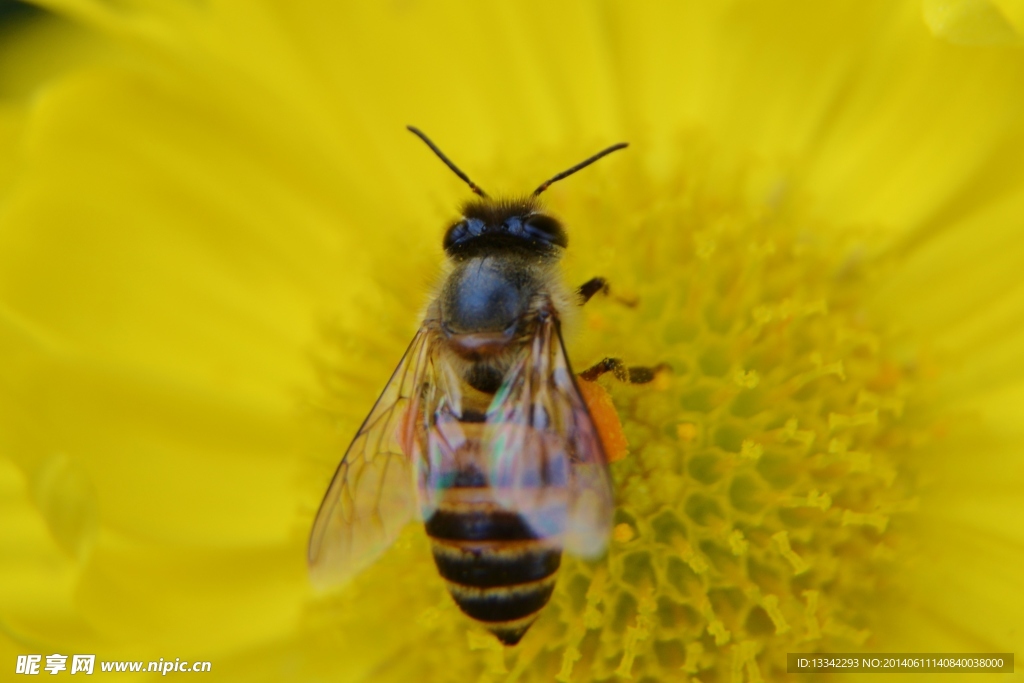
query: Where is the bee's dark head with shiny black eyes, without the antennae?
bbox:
[444,197,568,257]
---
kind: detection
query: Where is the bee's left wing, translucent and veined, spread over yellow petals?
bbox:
[308,326,434,586]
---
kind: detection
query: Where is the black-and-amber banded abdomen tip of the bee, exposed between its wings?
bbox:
[426,486,561,645]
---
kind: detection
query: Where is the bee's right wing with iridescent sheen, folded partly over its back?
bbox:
[483,316,614,557]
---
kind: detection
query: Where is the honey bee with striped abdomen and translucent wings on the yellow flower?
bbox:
[308,126,653,645]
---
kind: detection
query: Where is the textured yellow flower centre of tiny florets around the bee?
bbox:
[299,141,916,682]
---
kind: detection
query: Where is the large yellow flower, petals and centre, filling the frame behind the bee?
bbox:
[0,0,1024,682]
